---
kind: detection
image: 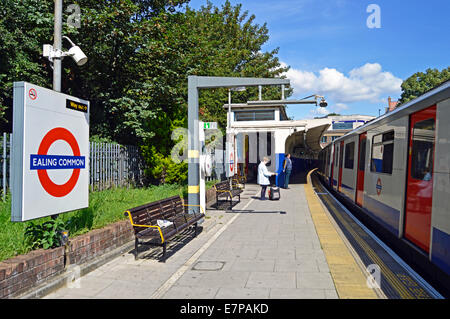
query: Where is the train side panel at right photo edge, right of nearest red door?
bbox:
[430,99,450,274]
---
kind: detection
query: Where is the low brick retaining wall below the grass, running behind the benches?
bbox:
[0,189,215,299]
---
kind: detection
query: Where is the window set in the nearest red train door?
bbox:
[411,118,436,181]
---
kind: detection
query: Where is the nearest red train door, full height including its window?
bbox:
[405,106,436,252]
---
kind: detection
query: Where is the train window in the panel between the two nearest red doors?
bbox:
[370,131,394,174]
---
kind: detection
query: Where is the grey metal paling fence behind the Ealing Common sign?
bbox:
[0,133,144,199]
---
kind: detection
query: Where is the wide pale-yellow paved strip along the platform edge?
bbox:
[304,171,378,299]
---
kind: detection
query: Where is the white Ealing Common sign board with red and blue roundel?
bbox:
[11,82,89,221]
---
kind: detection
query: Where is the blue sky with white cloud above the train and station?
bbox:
[185,0,450,119]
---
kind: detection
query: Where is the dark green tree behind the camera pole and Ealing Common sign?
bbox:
[0,0,188,138]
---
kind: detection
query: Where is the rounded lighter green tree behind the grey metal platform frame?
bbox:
[139,1,292,184]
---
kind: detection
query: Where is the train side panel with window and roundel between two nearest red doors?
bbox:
[364,116,409,237]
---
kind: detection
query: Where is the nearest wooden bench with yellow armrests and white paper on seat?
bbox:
[125,196,205,262]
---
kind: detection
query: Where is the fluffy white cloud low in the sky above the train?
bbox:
[284,63,402,105]
